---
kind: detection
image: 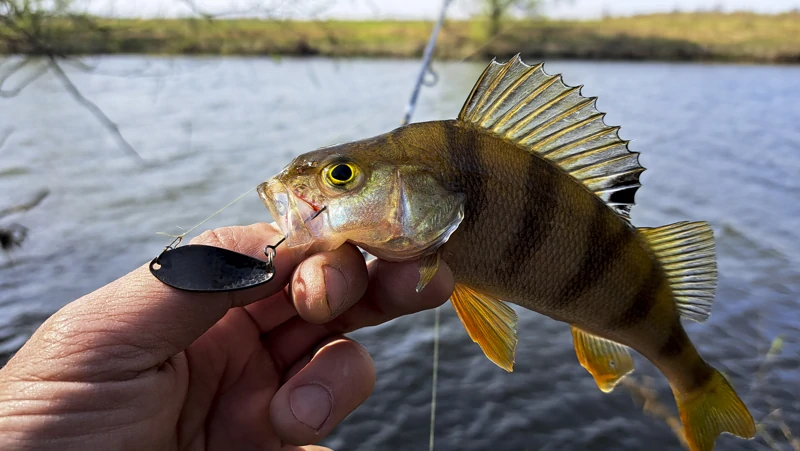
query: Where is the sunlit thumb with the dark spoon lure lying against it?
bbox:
[9,223,303,381]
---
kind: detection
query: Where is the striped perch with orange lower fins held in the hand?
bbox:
[257,55,756,451]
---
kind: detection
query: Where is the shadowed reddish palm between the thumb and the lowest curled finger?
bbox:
[175,308,282,450]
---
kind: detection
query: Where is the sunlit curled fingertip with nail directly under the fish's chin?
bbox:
[291,244,368,323]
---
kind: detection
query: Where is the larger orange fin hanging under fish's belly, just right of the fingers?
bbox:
[450,284,518,372]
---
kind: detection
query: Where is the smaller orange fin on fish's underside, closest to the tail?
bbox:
[571,326,633,393]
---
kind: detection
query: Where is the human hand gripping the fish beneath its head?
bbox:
[0,224,454,451]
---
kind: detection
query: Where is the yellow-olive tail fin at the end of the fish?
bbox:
[673,370,756,451]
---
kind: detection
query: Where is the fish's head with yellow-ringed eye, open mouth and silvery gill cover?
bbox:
[258,134,464,261]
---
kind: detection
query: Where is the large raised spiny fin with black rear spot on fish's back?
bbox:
[458,55,644,220]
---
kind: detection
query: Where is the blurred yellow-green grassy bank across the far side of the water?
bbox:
[0,13,800,63]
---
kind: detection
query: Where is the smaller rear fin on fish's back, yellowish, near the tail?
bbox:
[639,222,717,322]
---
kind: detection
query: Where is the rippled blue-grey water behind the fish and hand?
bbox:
[0,57,800,450]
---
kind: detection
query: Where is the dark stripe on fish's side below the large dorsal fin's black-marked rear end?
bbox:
[556,200,632,308]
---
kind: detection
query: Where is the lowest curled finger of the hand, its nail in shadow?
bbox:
[270,337,375,445]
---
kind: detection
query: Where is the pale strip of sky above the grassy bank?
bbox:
[82,0,800,19]
